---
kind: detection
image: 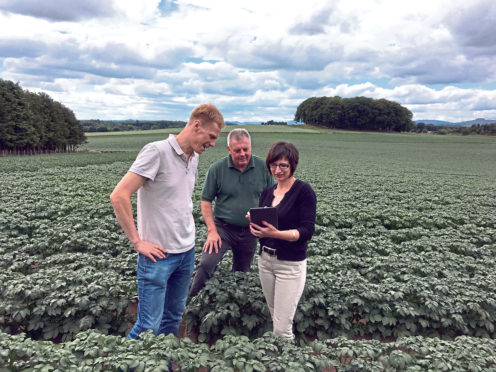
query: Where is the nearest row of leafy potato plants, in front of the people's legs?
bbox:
[0,331,496,372]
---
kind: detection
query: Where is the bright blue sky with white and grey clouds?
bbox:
[0,0,496,122]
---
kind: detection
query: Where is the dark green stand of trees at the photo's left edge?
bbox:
[0,79,86,155]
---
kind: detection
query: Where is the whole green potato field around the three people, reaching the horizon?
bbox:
[0,126,496,371]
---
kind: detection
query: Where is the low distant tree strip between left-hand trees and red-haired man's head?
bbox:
[81,119,186,133]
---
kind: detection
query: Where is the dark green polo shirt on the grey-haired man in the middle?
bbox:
[201,155,275,226]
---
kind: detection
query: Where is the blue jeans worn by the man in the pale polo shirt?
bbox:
[127,248,195,339]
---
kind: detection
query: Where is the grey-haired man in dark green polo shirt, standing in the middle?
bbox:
[189,128,274,296]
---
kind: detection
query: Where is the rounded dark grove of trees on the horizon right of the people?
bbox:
[295,96,415,132]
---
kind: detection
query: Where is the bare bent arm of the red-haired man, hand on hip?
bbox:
[110,172,165,262]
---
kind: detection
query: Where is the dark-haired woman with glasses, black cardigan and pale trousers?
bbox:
[250,142,317,339]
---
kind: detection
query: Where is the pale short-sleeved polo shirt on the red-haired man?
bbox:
[129,134,199,253]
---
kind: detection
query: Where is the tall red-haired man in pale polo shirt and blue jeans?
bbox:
[110,104,225,338]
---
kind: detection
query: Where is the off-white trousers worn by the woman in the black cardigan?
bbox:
[258,252,307,339]
